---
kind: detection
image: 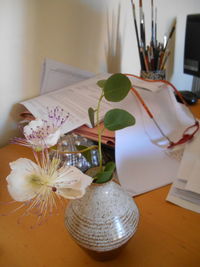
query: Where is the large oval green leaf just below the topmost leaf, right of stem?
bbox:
[104,108,135,131]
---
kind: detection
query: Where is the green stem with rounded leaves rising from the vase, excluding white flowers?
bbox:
[78,73,135,183]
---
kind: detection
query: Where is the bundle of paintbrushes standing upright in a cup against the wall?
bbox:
[131,0,175,75]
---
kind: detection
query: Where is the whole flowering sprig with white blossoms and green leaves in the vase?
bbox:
[6,74,135,225]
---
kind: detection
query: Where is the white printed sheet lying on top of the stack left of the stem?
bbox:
[21,74,111,133]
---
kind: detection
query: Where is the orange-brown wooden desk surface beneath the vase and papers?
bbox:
[0,101,200,267]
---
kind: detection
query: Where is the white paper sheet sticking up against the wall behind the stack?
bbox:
[40,58,95,94]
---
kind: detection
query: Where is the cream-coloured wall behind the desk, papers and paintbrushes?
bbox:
[0,0,200,146]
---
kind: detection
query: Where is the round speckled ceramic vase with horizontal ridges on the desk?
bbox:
[65,181,139,260]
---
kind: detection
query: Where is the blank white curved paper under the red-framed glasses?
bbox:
[116,78,194,196]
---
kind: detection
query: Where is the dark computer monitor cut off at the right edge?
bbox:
[184,14,200,77]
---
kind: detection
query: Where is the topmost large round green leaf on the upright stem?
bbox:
[103,73,131,102]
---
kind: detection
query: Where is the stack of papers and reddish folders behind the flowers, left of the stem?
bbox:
[20,59,115,147]
